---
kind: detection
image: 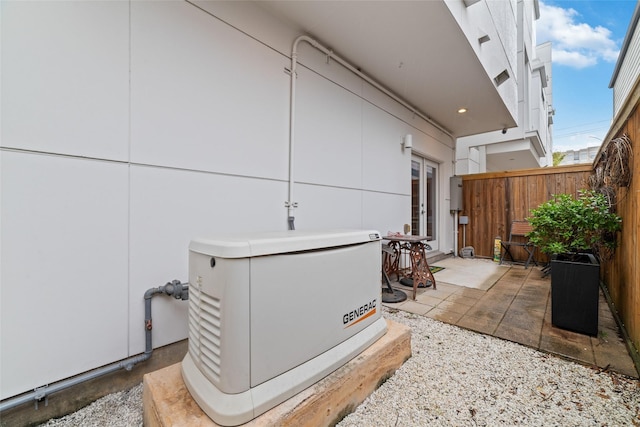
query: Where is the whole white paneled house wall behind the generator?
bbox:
[0,1,453,399]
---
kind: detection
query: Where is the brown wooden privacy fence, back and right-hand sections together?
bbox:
[458,79,640,371]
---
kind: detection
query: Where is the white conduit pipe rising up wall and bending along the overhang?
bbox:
[285,35,453,230]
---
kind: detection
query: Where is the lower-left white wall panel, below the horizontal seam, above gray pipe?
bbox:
[0,151,128,398]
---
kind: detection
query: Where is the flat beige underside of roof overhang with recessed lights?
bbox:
[257,1,515,137]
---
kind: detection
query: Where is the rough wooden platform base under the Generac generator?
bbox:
[143,320,411,427]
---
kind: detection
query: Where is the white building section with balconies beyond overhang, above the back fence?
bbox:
[456,0,554,175]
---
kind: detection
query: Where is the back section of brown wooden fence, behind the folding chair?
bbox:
[458,164,592,262]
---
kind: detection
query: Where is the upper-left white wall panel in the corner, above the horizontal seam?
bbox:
[1,1,129,160]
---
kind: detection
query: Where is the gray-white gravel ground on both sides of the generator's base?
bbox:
[43,308,640,427]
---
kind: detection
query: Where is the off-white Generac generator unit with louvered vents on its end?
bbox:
[182,230,386,426]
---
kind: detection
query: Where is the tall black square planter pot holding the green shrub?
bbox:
[551,254,600,336]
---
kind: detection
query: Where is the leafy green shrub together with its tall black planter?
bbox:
[528,190,622,336]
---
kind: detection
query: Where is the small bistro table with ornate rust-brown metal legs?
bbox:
[382,234,436,300]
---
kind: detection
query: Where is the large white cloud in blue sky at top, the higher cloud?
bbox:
[536,2,618,68]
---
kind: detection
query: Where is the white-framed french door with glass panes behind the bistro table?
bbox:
[411,155,439,250]
